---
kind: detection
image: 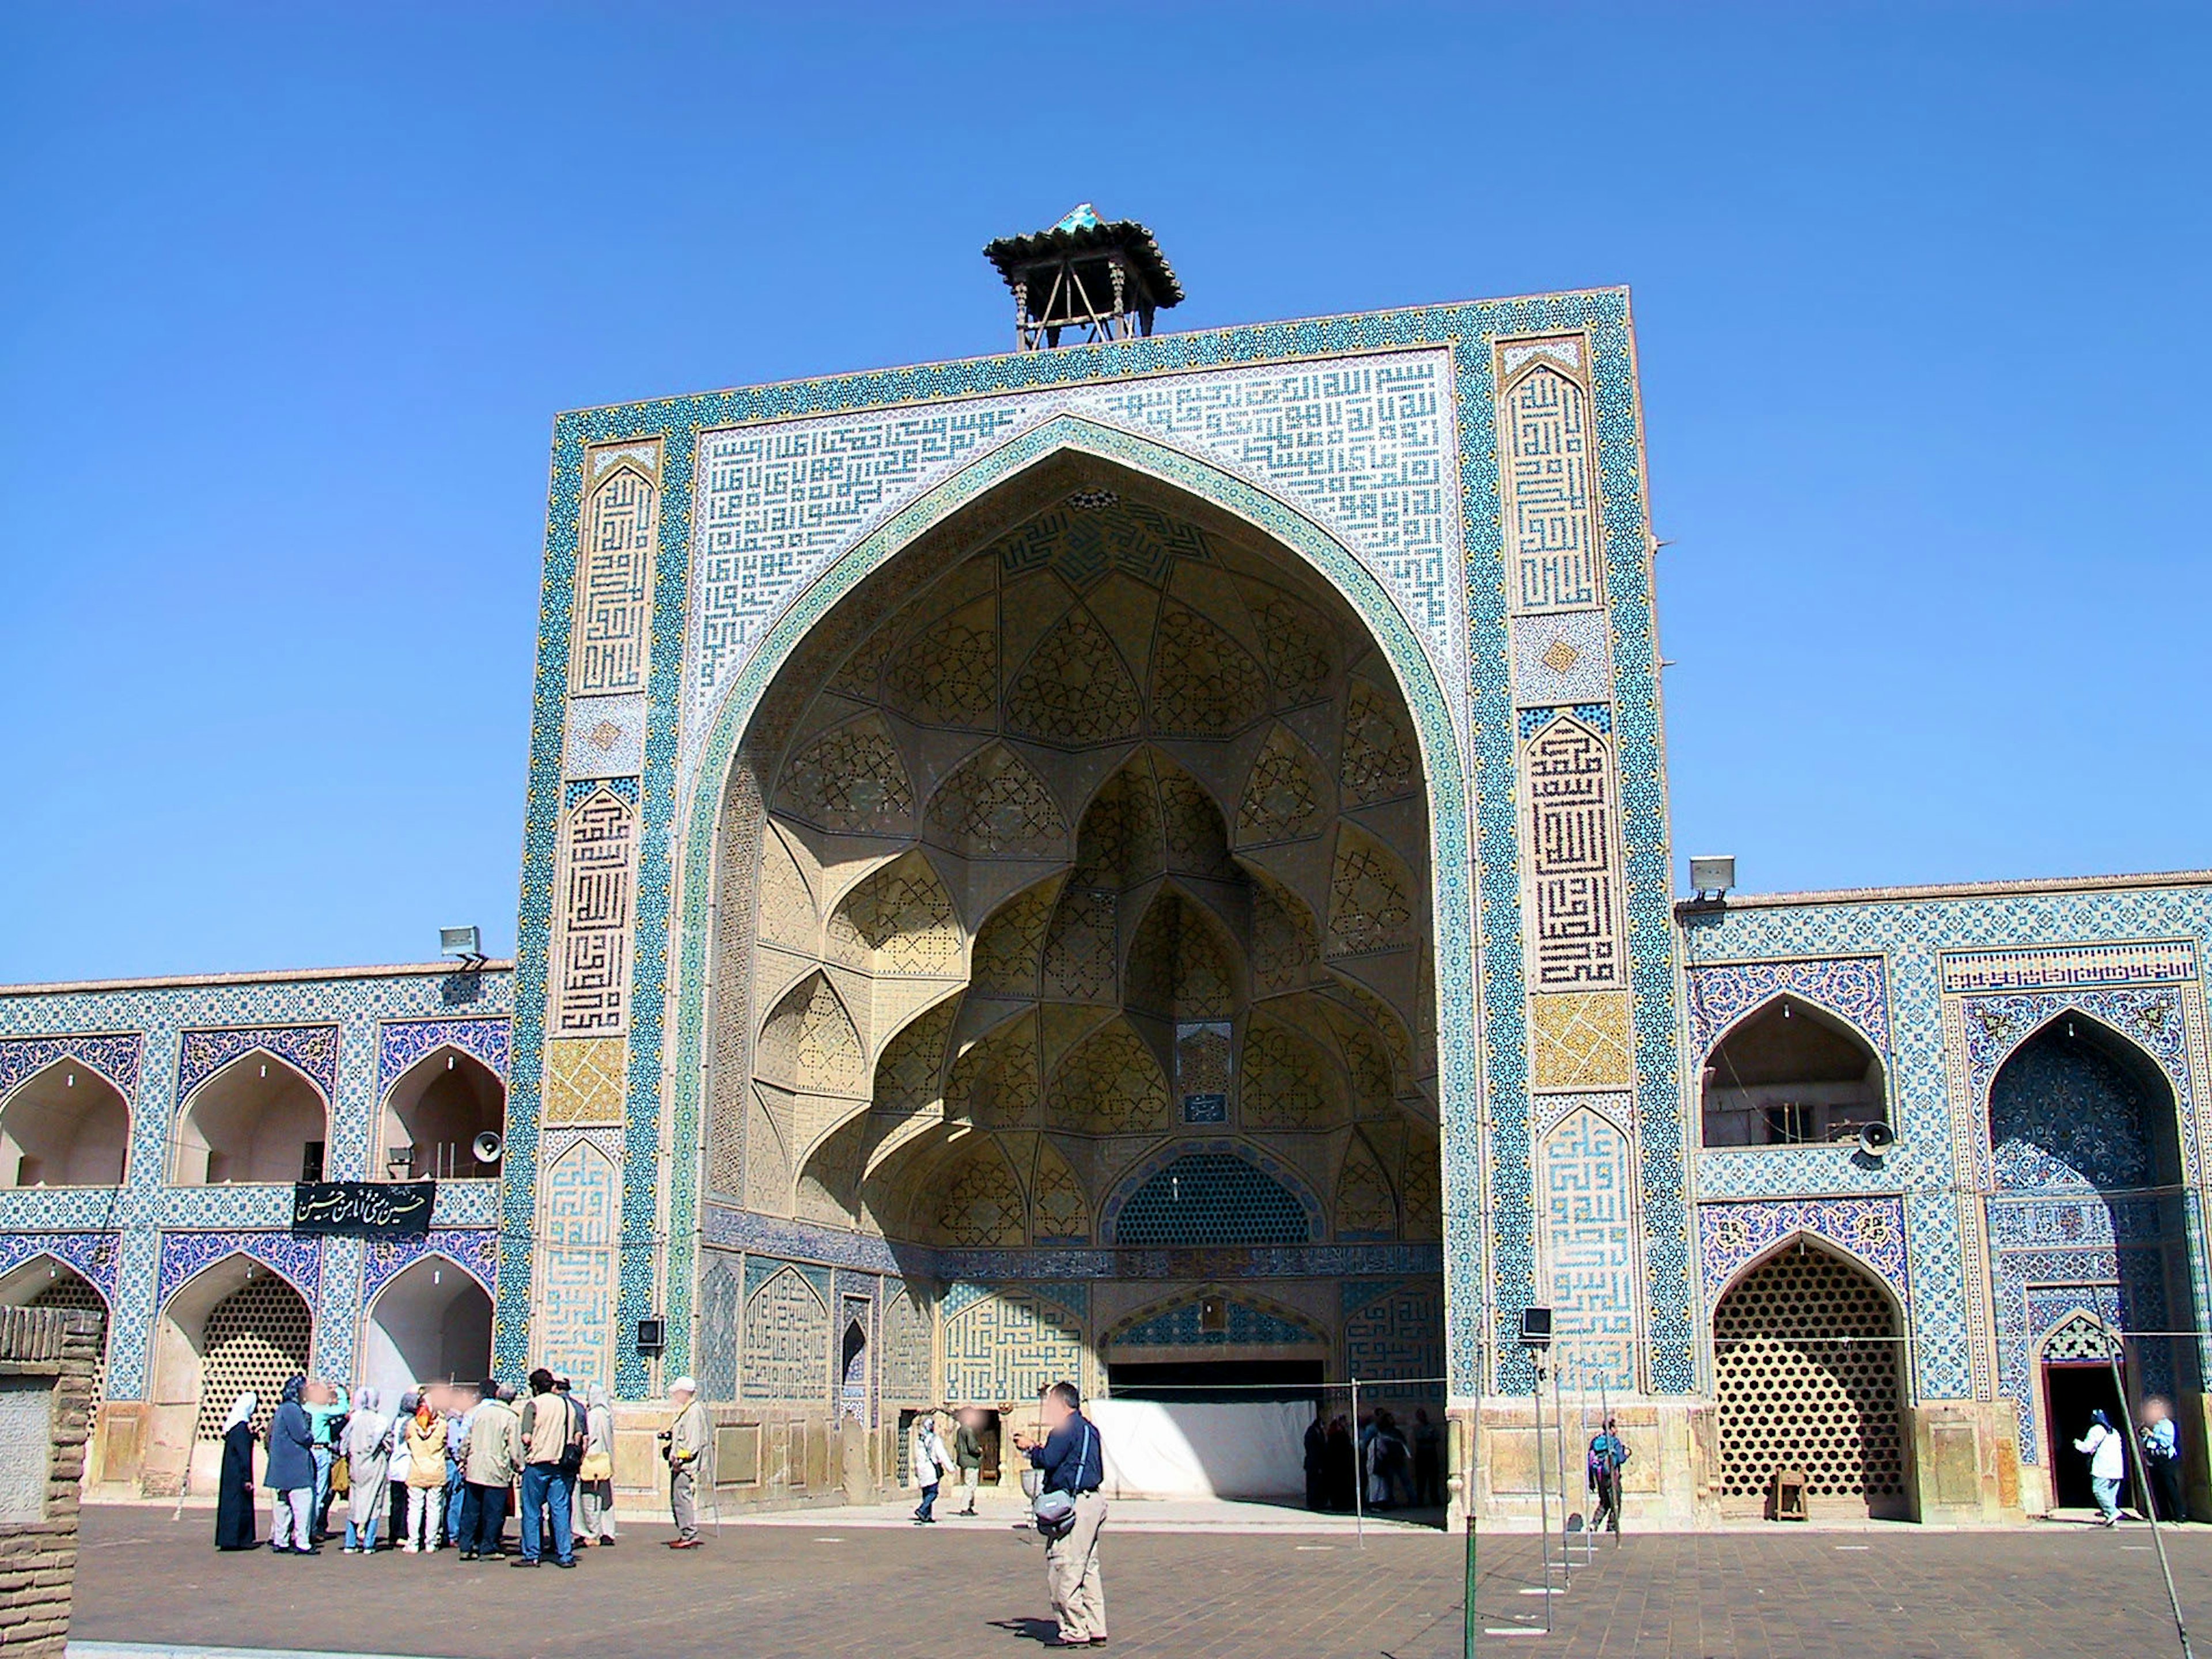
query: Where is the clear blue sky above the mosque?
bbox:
[0,2,2212,980]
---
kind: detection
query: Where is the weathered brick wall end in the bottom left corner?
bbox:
[0,1307,102,1659]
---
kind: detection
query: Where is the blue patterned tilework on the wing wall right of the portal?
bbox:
[1683,878,2212,1433]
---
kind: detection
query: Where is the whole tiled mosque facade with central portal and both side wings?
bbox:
[0,231,2212,1524]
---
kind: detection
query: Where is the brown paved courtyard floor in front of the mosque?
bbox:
[71,1504,2212,1659]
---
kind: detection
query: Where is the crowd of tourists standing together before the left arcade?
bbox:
[214,1367,632,1566]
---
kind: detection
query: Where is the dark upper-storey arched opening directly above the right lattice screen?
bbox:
[1701,995,1889,1146]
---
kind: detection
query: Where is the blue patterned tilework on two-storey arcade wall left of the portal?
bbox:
[0,967,511,1400]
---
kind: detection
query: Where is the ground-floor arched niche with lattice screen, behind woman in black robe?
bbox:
[146,1252,314,1493]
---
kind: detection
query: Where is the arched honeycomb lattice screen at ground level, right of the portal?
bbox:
[1712,1250,1904,1498]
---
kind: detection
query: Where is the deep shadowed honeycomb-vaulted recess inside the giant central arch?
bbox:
[684,451,1471,1393]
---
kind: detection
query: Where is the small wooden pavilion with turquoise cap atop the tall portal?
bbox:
[982,201,1183,352]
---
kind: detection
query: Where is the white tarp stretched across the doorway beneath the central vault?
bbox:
[1084,1400,1314,1498]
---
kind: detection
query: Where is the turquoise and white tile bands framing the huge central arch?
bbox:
[500,292,1692,1398]
